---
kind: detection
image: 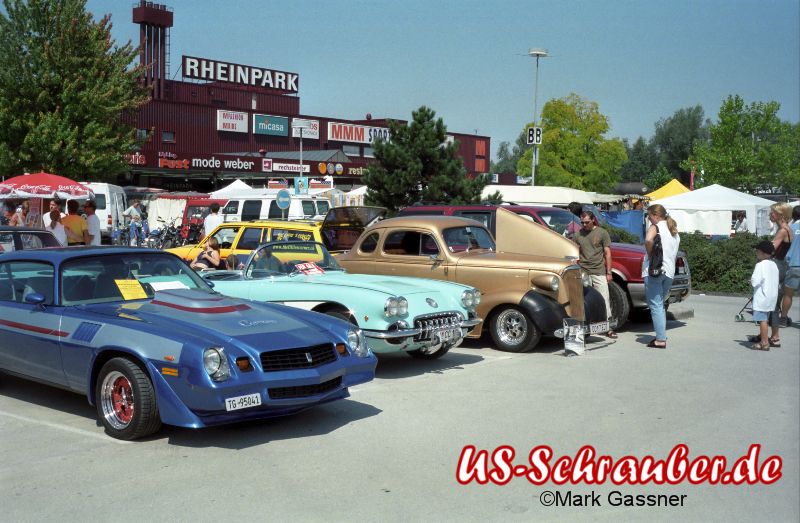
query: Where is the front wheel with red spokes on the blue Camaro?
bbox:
[94,358,161,440]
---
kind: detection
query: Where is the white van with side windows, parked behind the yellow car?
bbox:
[222,194,331,222]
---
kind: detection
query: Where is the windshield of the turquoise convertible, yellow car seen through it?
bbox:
[245,242,342,279]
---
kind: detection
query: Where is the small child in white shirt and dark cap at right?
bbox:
[750,240,779,350]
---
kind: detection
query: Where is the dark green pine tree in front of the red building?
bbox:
[362,106,488,213]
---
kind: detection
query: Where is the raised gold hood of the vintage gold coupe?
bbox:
[495,207,578,260]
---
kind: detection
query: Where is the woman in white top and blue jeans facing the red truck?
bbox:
[642,204,681,349]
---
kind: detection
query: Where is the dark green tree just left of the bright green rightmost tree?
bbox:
[652,105,710,185]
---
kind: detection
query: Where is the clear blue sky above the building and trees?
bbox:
[87,0,800,157]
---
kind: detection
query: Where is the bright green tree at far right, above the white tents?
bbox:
[681,95,800,193]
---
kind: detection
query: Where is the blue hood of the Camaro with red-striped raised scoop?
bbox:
[87,289,332,347]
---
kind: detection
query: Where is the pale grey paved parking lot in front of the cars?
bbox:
[0,295,800,521]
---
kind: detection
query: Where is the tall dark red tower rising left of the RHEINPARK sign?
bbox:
[133,0,172,100]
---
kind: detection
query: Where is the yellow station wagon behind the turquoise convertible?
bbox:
[166,220,322,268]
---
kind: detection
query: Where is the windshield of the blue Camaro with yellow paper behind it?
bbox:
[61,252,213,305]
